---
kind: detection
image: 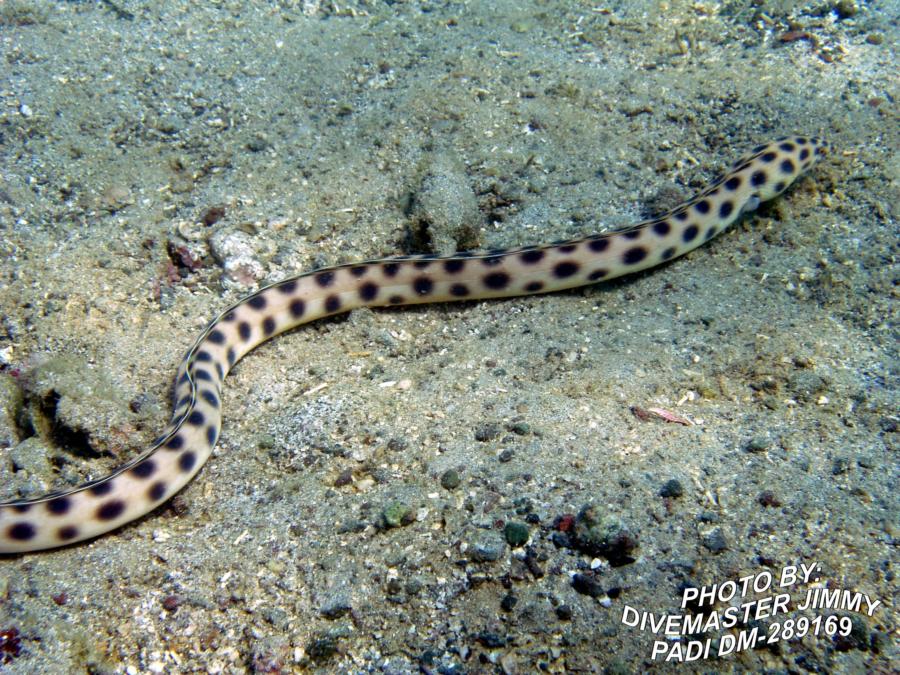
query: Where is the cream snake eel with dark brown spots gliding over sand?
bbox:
[0,136,826,553]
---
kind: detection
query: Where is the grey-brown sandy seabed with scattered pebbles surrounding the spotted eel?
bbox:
[0,0,900,673]
